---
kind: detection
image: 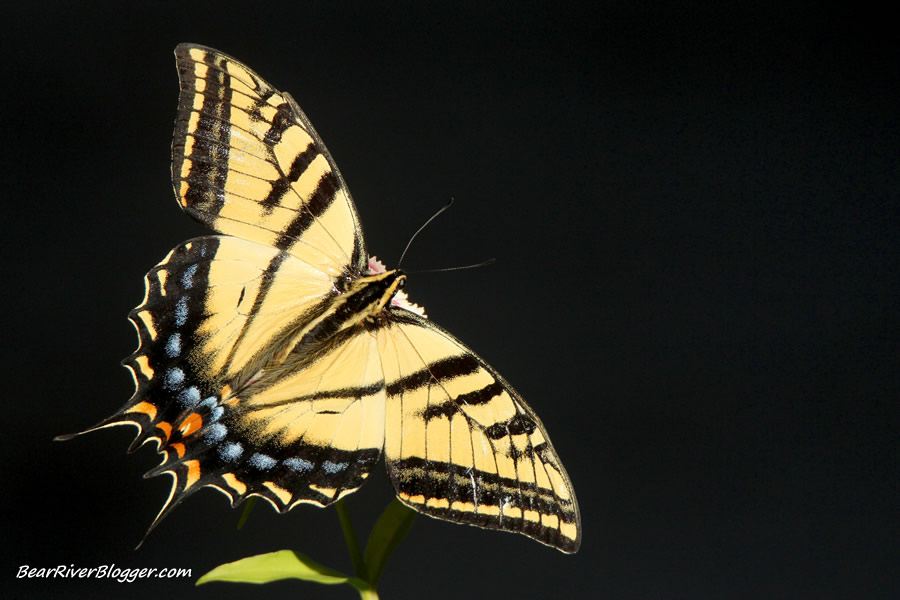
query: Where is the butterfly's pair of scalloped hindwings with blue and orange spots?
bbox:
[93,236,385,522]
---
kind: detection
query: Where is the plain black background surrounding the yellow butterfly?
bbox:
[0,1,900,599]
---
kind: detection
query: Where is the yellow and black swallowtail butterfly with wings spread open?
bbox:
[61,44,581,553]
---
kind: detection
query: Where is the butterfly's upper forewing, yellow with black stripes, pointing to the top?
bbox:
[172,44,368,270]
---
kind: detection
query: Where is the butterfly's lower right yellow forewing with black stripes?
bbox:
[379,309,580,552]
